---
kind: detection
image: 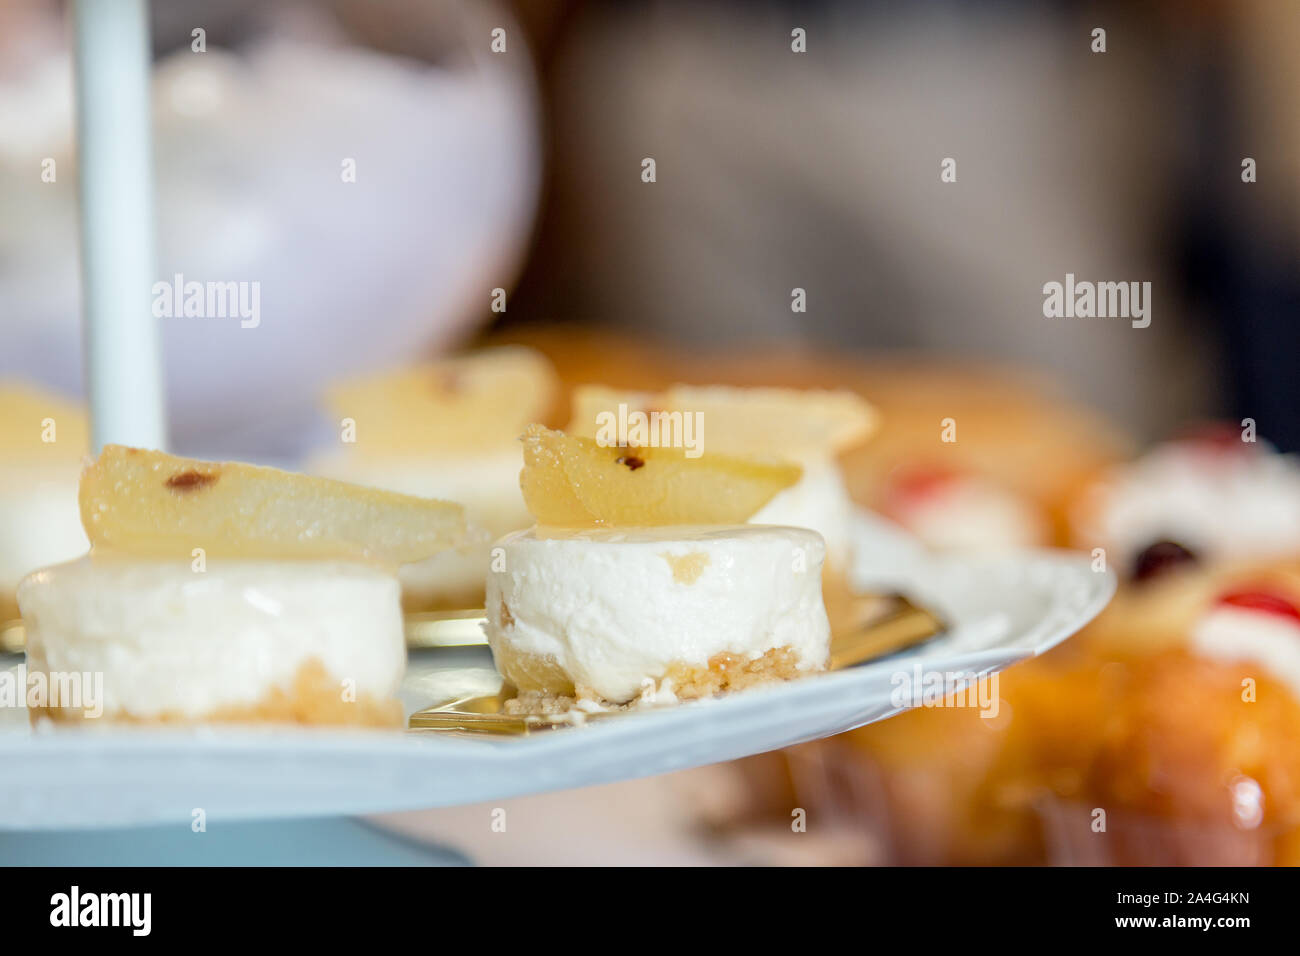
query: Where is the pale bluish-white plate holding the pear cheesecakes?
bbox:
[0,514,1115,829]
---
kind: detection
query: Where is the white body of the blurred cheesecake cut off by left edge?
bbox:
[0,462,90,618]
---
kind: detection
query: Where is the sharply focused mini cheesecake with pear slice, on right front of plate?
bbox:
[496,425,831,711]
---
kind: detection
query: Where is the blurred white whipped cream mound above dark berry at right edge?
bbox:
[1083,441,1300,566]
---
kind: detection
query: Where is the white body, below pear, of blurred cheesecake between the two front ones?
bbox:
[308,442,533,607]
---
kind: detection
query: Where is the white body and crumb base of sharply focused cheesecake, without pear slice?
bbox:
[486,525,831,702]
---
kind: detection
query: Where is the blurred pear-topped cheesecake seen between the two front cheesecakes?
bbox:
[308,346,558,610]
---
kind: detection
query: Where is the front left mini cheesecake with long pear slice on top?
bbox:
[18,445,464,726]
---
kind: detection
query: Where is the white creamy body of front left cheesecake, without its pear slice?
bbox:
[18,558,406,723]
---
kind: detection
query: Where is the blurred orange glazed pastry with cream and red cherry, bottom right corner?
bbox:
[991,563,1300,865]
